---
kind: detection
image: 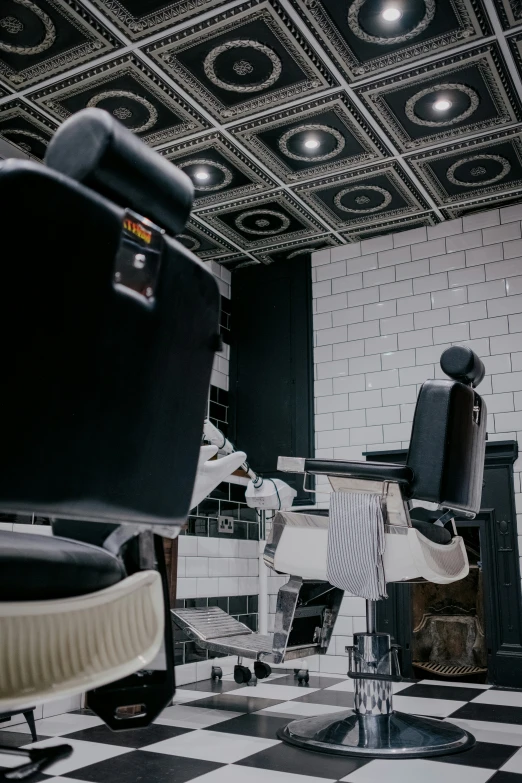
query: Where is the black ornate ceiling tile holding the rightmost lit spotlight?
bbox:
[356,44,522,151]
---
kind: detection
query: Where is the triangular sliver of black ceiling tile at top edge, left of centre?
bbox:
[87,0,223,41]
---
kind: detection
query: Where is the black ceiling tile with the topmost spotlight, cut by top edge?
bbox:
[292,0,488,81]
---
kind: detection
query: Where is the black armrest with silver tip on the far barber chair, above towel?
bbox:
[277,457,413,487]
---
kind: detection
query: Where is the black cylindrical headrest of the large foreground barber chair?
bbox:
[45,109,194,236]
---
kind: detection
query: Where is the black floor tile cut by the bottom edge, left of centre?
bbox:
[64,750,223,783]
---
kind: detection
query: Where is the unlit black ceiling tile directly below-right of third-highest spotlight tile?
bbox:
[295,161,428,229]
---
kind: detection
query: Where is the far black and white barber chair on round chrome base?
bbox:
[274,346,487,758]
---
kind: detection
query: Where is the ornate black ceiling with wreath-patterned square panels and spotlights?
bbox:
[0,0,522,269]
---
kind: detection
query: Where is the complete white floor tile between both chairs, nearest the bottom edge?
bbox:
[141,730,281,764]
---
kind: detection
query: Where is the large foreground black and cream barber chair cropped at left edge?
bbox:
[0,109,220,778]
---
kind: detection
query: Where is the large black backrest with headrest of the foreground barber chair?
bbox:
[0,110,219,526]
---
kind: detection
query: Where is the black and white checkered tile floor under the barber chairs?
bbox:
[0,672,522,783]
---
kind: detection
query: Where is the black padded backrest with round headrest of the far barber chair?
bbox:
[407,346,487,516]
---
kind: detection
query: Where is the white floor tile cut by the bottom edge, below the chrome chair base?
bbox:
[341,759,495,783]
